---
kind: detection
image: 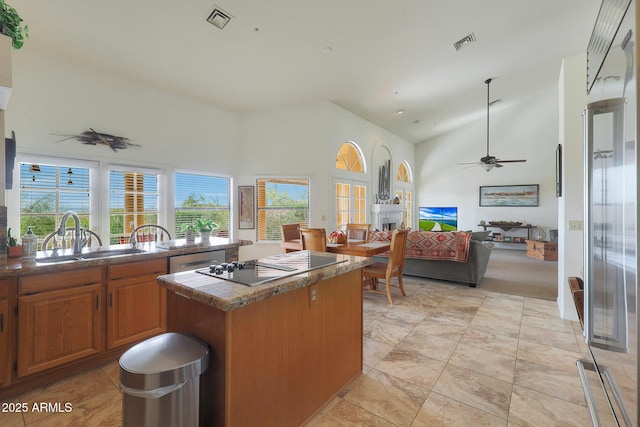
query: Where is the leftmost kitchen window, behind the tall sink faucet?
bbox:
[18,158,96,244]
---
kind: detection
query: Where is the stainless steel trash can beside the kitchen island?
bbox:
[120,332,209,427]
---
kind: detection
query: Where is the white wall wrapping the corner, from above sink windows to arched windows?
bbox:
[6,46,414,257]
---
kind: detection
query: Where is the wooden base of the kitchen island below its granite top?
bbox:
[167,269,363,426]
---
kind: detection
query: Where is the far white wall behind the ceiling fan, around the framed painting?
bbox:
[416,84,558,236]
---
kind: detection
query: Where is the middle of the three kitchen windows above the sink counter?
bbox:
[109,168,163,244]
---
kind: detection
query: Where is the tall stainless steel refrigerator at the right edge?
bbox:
[578,0,639,426]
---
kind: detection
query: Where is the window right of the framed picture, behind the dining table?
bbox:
[256,178,310,242]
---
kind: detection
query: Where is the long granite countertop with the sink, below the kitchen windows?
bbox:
[0,237,252,279]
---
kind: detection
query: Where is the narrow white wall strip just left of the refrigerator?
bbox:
[558,54,587,321]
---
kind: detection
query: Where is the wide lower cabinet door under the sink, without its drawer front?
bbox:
[18,284,104,377]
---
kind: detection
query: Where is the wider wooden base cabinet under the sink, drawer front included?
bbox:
[17,268,104,377]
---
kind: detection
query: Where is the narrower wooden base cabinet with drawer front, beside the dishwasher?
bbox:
[107,258,167,349]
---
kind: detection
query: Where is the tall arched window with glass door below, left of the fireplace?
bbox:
[334,142,367,229]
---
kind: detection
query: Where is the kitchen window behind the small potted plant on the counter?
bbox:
[173,173,231,241]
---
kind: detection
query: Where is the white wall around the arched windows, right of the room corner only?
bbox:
[237,102,414,259]
